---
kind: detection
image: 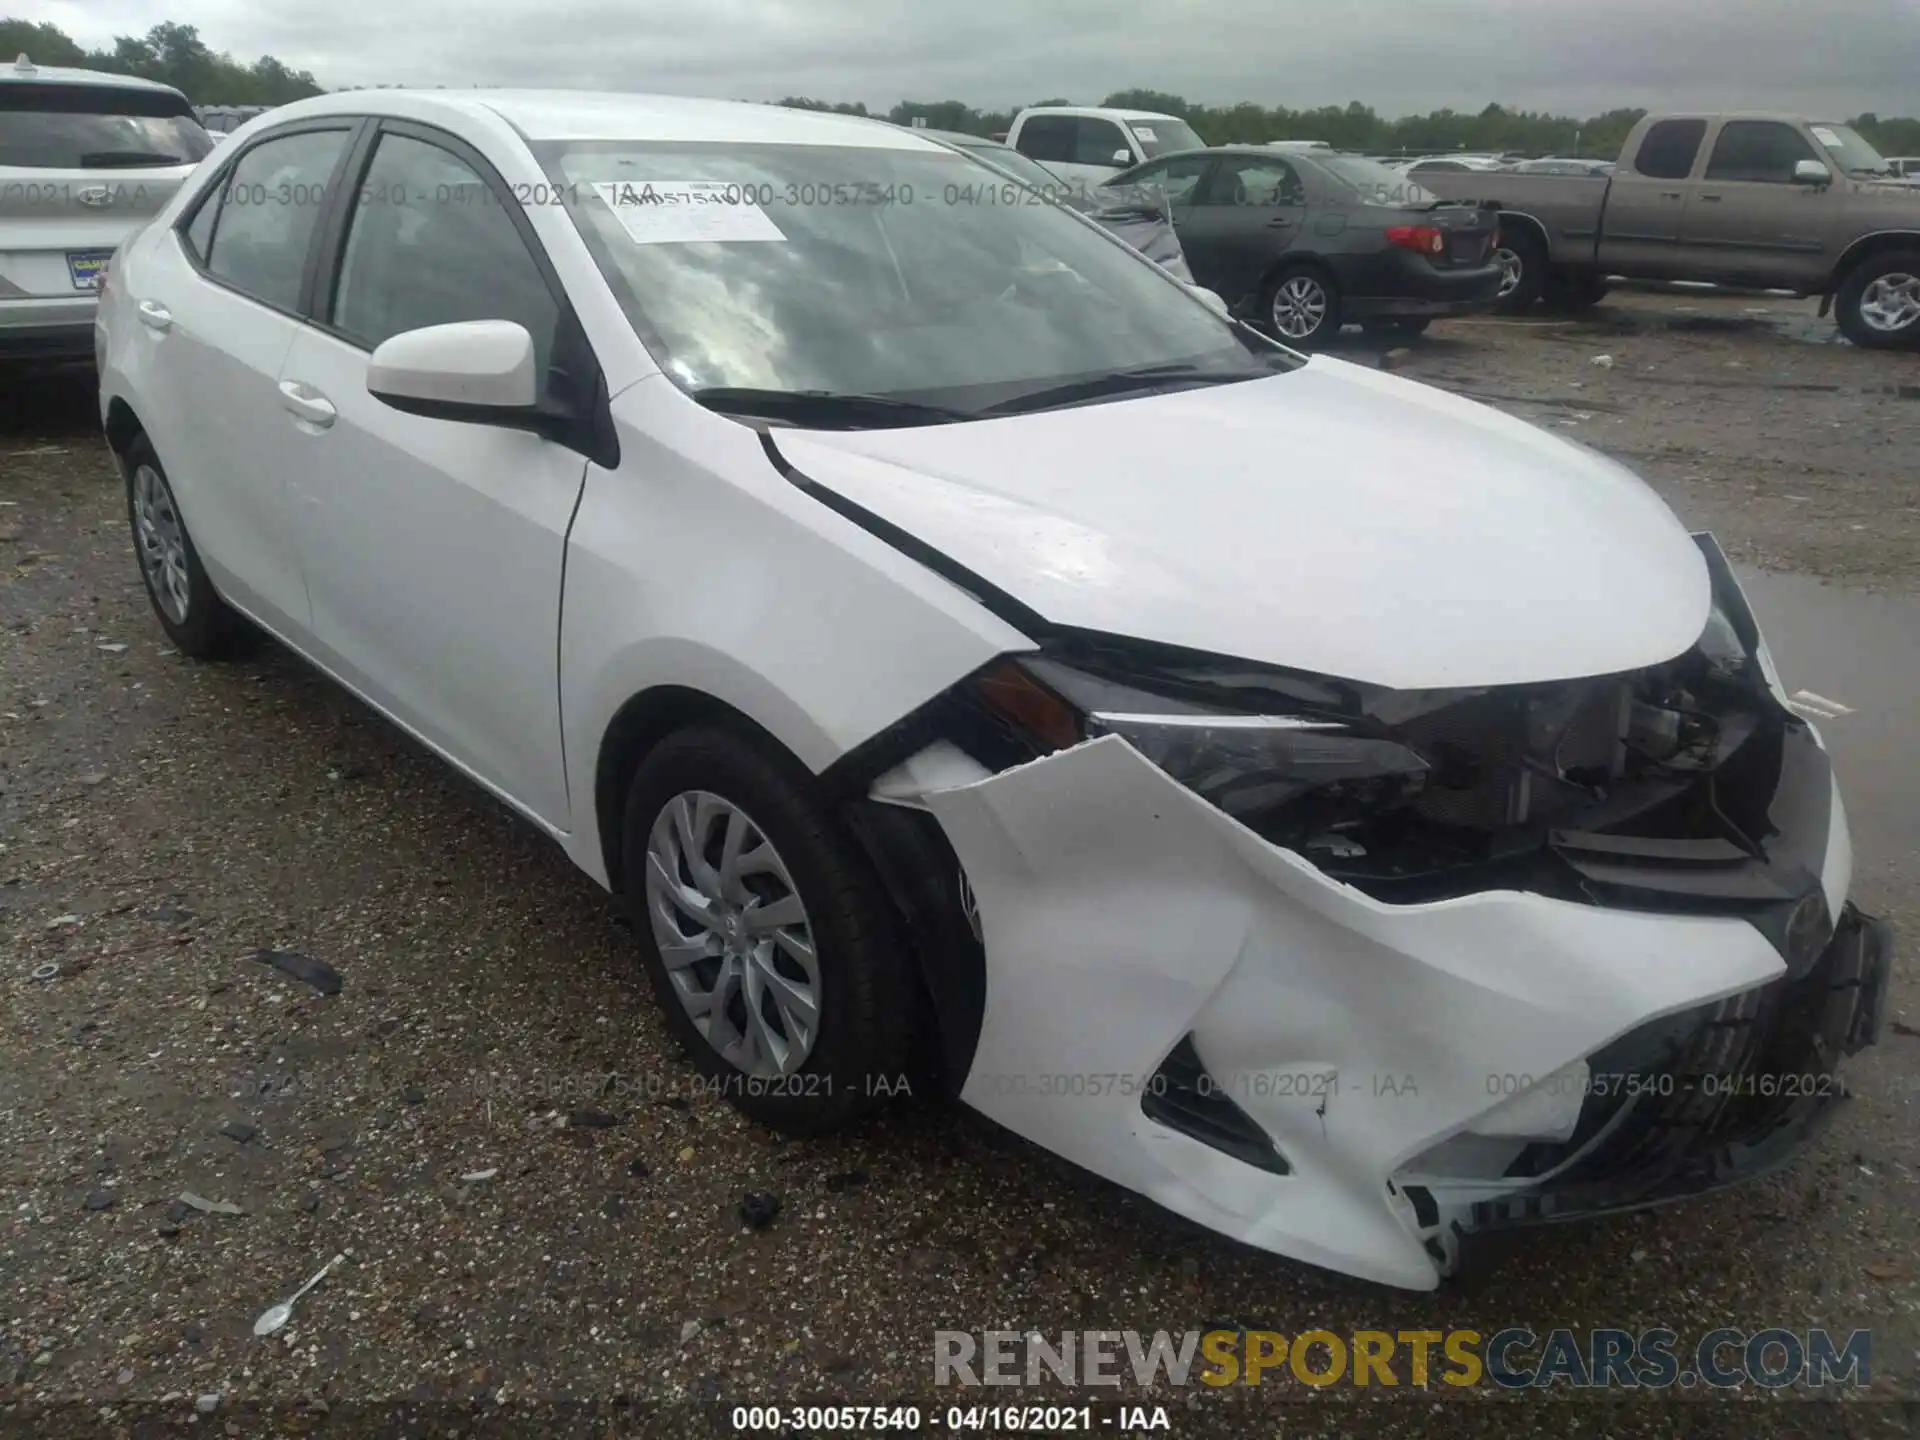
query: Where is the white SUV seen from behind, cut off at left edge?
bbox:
[0,56,213,372]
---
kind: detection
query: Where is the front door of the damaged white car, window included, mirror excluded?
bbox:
[278,123,586,829]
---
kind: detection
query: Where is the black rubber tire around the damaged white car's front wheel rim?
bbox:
[622,726,922,1135]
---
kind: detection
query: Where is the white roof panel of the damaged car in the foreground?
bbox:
[259,88,948,150]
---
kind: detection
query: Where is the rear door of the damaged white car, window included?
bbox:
[113,117,357,639]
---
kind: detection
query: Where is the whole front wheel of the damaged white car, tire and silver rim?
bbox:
[622,728,920,1135]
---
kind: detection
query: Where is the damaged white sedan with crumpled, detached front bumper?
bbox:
[98,90,1889,1286]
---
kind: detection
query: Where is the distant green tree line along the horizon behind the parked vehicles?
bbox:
[0,19,1920,159]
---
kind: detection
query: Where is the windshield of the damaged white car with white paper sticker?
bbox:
[536,140,1294,422]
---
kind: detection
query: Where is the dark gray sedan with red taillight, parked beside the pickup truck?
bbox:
[1112,146,1500,346]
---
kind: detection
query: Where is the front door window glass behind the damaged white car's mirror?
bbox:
[332,134,561,376]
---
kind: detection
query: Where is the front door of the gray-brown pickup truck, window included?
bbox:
[1686,119,1839,286]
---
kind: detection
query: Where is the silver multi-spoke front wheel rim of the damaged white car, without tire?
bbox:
[647,791,822,1077]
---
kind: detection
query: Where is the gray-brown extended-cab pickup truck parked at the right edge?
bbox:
[1419,113,1920,349]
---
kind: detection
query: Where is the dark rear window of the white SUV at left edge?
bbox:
[0,83,213,171]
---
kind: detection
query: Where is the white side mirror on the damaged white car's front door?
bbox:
[367,321,547,430]
